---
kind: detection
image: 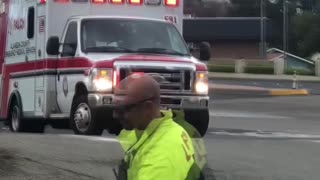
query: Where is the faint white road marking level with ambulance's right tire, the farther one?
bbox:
[209,110,289,119]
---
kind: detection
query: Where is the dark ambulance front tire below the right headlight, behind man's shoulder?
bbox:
[185,110,210,137]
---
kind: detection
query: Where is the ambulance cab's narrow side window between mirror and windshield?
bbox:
[61,22,77,56]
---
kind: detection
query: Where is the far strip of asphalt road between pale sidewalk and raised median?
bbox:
[211,78,320,94]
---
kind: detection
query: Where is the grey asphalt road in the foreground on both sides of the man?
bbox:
[0,95,320,180]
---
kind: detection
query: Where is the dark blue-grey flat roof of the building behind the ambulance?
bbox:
[183,17,272,41]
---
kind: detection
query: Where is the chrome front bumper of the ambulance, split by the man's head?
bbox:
[88,94,210,110]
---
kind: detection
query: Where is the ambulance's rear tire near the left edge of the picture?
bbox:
[9,100,45,133]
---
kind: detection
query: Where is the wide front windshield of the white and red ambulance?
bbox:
[81,19,190,56]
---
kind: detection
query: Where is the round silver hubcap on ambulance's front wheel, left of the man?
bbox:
[74,103,91,132]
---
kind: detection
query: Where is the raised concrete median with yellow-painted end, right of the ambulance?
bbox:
[209,83,311,96]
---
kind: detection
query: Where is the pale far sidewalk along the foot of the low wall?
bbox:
[209,72,320,83]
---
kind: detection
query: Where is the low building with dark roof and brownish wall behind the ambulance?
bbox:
[183,17,272,59]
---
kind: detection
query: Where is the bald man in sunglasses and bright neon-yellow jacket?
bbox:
[115,74,200,180]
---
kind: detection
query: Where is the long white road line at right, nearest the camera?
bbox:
[210,131,320,139]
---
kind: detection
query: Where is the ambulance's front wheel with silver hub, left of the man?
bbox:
[70,95,104,135]
